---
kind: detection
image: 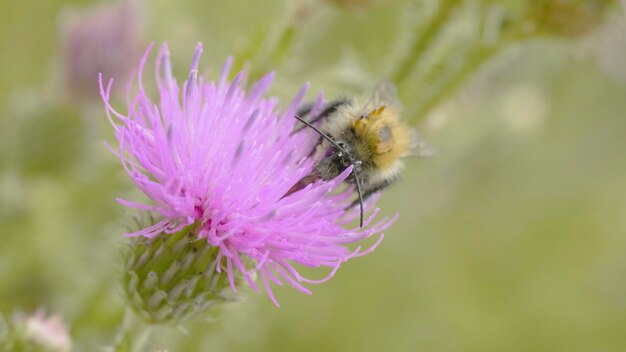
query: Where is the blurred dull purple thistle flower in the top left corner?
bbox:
[59,0,142,100]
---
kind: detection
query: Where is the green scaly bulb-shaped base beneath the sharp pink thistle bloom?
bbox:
[123,226,241,324]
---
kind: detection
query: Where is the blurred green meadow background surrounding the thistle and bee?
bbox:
[0,0,626,351]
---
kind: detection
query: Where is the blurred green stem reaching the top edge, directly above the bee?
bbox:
[391,0,460,87]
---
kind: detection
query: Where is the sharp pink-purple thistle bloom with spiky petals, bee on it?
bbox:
[100,44,395,305]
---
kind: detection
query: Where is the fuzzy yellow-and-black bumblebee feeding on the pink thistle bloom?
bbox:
[287,82,433,226]
